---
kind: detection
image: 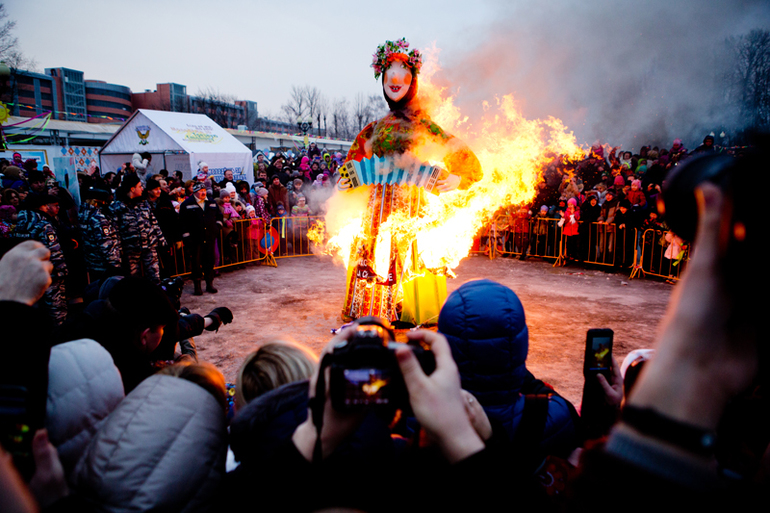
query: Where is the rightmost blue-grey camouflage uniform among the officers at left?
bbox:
[110,198,166,284]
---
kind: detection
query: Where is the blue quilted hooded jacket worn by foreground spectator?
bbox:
[438,280,577,456]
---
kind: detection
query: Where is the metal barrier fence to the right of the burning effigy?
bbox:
[479,216,688,280]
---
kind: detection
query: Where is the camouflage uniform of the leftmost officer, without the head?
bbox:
[13,210,67,325]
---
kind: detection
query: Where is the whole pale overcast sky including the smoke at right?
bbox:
[4,0,770,148]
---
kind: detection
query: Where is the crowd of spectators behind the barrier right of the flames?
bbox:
[486,135,734,272]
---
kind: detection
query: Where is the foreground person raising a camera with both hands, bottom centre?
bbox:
[228,326,511,511]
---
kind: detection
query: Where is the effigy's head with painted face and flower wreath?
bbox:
[372,38,422,110]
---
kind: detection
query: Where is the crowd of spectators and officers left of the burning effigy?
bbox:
[0,143,343,325]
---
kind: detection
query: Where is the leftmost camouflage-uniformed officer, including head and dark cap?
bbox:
[14,194,67,326]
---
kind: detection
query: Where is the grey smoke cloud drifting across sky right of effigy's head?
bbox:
[434,0,770,150]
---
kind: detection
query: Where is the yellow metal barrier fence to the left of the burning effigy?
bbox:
[166,216,323,276]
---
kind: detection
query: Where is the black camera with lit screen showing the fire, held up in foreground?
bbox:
[329,317,436,411]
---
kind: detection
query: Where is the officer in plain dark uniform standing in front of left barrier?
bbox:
[179,182,222,296]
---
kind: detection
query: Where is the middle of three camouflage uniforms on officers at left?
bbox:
[78,203,122,281]
